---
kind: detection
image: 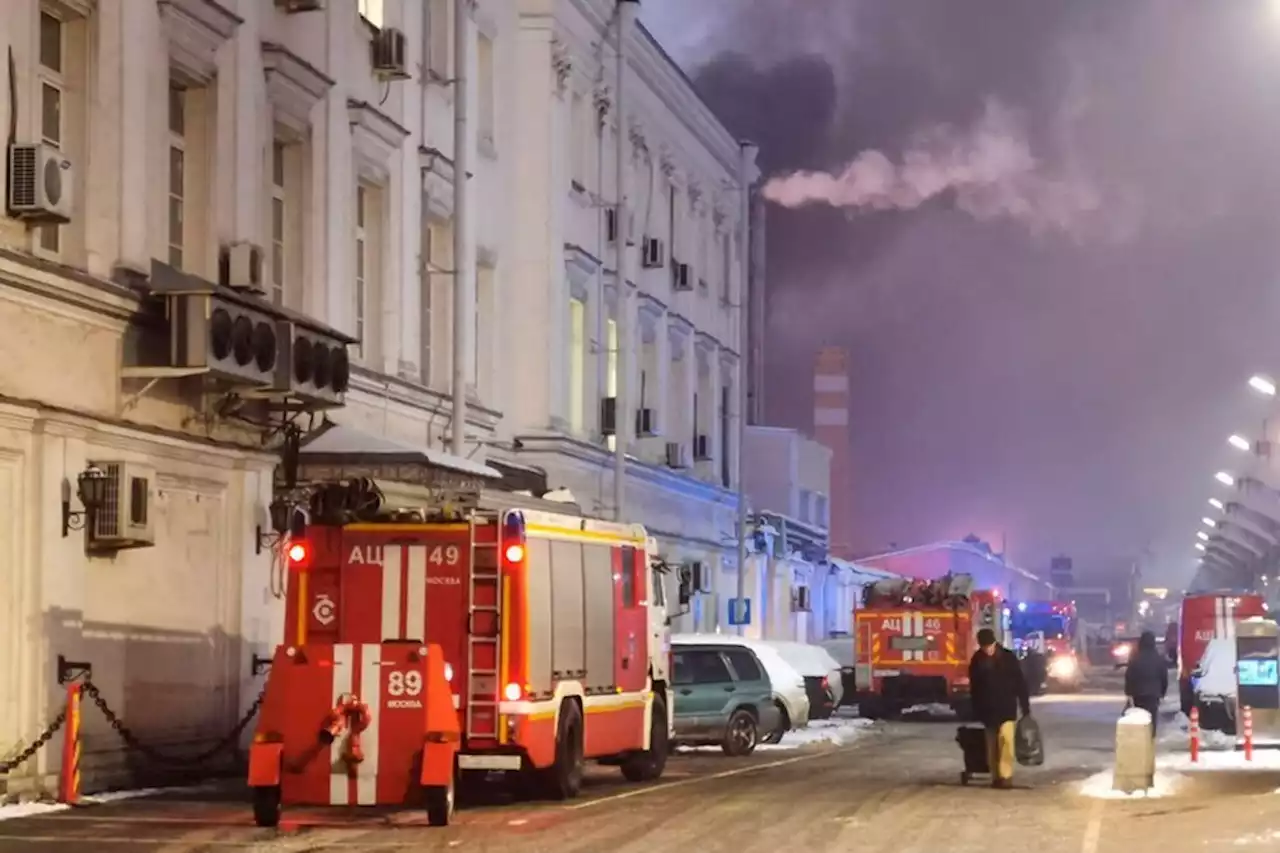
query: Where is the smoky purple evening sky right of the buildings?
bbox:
[643,0,1280,584]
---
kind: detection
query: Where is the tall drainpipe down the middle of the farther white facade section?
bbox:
[613,0,640,521]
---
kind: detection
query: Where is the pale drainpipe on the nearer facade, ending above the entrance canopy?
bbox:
[449,0,476,456]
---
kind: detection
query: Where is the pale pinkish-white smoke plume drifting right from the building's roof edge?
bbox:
[764,99,1102,234]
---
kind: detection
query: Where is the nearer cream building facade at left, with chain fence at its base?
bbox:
[0,0,512,788]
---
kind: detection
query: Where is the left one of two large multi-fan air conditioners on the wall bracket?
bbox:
[168,293,280,388]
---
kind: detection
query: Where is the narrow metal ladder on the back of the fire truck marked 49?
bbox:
[466,524,502,738]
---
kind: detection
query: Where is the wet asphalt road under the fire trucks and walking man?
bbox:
[0,676,1280,853]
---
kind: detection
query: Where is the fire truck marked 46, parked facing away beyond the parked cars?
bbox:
[854,575,1007,719]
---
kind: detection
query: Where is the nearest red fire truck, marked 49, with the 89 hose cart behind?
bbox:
[251,491,673,824]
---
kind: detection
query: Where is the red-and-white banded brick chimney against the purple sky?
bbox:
[813,347,855,560]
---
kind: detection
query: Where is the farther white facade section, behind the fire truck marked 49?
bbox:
[495,0,756,630]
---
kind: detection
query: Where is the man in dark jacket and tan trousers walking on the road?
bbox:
[969,628,1032,788]
